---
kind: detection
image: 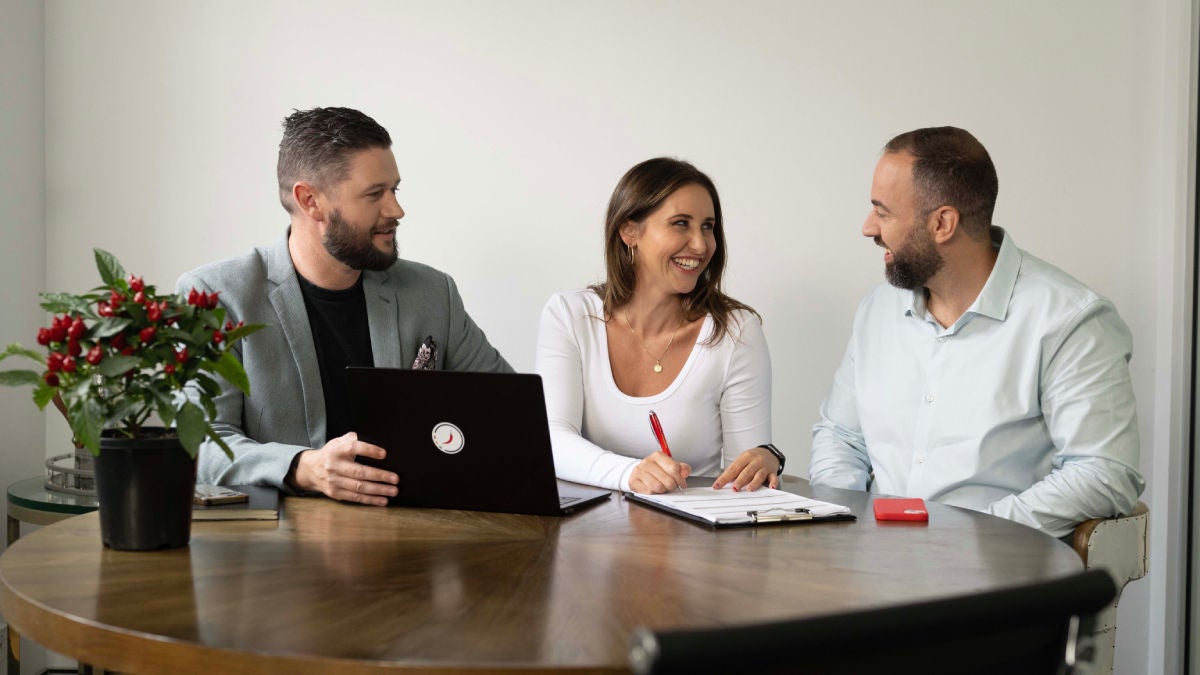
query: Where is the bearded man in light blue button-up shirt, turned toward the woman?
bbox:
[809,127,1145,537]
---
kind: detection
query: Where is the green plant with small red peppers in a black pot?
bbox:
[0,249,263,550]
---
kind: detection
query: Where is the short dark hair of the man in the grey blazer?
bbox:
[276,108,391,214]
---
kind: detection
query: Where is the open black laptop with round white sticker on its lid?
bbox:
[346,368,612,515]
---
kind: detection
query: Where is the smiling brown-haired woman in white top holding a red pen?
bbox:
[538,157,784,494]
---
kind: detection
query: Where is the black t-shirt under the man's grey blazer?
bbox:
[296,274,374,441]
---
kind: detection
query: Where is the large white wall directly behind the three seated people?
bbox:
[35,0,1196,673]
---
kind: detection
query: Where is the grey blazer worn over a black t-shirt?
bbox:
[175,234,512,490]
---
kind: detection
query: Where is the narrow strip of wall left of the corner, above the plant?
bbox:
[0,0,46,528]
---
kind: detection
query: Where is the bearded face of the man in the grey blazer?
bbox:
[322,148,404,270]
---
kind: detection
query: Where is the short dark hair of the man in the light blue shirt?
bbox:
[883,126,1000,239]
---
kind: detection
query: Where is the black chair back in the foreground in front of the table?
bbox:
[630,571,1116,675]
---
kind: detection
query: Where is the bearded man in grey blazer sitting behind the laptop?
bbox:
[176,108,512,506]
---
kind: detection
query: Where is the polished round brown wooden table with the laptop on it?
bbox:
[0,479,1082,674]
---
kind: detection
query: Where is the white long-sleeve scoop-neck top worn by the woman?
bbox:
[536,291,770,490]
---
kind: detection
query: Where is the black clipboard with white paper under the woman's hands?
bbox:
[625,486,857,530]
